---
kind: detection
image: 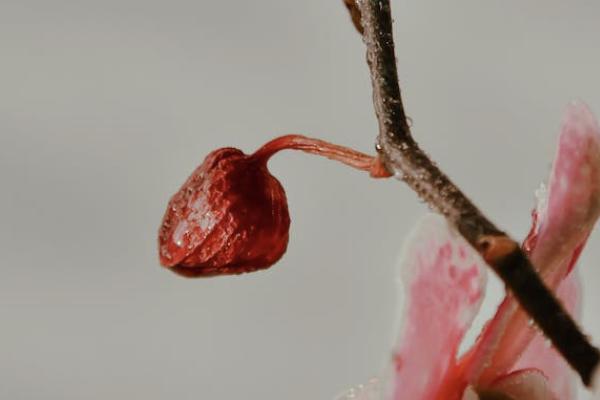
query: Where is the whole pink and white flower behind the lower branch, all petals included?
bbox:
[340,103,600,400]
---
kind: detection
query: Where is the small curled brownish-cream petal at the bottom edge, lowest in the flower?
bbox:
[489,369,566,400]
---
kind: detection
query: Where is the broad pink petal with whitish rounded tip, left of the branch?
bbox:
[390,215,486,400]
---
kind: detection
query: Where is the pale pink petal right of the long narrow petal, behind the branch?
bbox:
[513,271,581,400]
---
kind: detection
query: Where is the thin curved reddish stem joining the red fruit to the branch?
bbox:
[252,135,392,178]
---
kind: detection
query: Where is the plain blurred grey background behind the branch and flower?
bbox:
[0,0,600,400]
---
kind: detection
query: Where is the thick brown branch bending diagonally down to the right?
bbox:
[354,0,600,386]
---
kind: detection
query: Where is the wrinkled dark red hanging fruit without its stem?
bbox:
[158,148,290,277]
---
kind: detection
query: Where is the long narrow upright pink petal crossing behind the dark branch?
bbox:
[461,103,600,385]
